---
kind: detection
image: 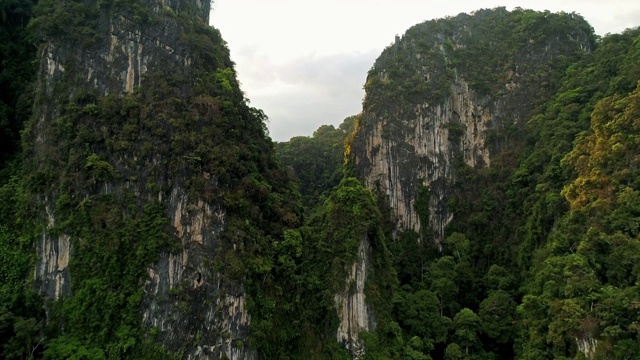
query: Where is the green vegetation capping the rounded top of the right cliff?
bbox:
[364,7,595,116]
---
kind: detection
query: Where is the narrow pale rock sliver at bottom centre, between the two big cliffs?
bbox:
[335,237,375,359]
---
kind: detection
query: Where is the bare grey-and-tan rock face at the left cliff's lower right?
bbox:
[142,188,256,360]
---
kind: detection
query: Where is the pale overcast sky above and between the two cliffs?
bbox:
[211,0,640,141]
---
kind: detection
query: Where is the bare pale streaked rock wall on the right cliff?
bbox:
[356,78,496,242]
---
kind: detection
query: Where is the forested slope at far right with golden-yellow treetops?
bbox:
[432,25,640,359]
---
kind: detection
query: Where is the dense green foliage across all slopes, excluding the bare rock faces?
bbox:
[0,0,640,360]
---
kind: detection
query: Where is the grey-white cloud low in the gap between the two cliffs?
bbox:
[239,51,378,141]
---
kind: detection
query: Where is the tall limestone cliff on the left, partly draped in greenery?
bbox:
[25,0,295,359]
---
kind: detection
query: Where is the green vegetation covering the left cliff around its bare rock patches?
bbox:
[0,0,299,359]
